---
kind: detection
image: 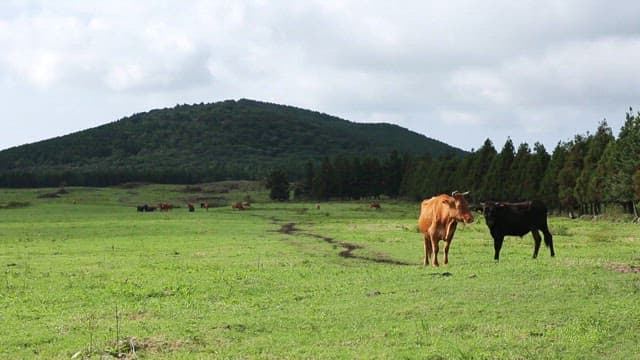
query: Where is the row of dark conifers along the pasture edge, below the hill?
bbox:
[267,109,640,216]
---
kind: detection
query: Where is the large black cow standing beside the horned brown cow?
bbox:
[482,200,555,261]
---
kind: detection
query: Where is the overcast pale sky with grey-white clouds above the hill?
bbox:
[0,0,640,152]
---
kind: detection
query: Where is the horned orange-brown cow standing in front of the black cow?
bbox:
[418,191,473,266]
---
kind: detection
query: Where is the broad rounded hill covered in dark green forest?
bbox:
[0,99,464,187]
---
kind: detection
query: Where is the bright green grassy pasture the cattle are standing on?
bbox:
[0,185,640,359]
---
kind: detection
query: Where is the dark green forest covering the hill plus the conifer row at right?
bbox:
[0,99,640,216]
